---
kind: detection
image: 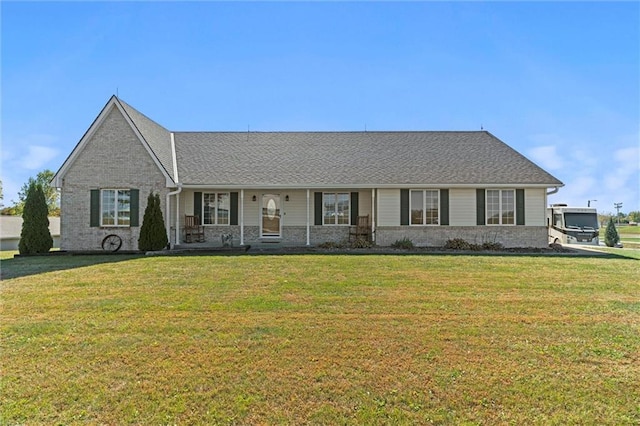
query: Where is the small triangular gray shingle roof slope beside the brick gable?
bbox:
[116,98,175,181]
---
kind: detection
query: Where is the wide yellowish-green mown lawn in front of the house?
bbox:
[0,255,640,425]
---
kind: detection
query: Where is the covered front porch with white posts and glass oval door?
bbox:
[167,188,375,248]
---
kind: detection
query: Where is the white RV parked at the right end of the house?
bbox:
[547,204,600,246]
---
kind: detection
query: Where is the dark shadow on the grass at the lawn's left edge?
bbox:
[0,252,144,280]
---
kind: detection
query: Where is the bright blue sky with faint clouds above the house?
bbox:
[0,1,640,216]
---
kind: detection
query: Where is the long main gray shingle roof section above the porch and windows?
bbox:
[175,131,562,187]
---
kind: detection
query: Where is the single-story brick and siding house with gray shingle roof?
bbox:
[53,96,563,250]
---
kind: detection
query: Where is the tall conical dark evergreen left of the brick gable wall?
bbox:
[18,182,53,254]
